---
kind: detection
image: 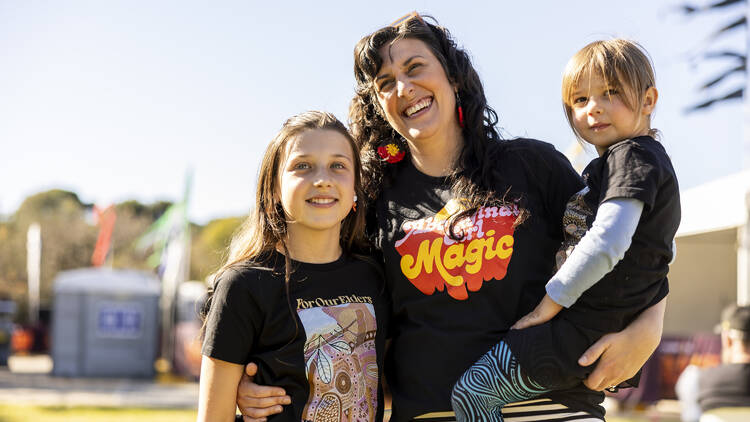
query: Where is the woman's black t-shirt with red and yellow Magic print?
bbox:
[376,139,603,422]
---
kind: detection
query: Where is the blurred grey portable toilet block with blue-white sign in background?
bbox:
[52,268,160,377]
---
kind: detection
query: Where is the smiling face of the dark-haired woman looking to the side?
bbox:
[374,38,458,144]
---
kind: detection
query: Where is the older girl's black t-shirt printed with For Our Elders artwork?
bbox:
[202,254,389,422]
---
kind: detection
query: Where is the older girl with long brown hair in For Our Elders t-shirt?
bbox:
[198,111,387,422]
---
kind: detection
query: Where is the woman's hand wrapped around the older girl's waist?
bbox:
[237,363,292,422]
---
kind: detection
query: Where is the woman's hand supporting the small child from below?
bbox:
[578,298,667,391]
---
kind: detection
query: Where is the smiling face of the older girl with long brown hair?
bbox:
[278,129,356,236]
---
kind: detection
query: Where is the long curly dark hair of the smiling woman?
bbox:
[349,17,527,237]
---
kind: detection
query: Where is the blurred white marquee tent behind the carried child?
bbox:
[664,170,750,335]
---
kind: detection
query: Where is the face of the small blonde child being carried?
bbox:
[569,74,657,155]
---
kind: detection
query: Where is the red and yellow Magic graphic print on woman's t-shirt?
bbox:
[396,199,519,300]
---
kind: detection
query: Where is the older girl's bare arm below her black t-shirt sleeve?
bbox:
[198,356,243,422]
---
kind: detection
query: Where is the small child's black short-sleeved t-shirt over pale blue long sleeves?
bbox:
[564,136,680,333]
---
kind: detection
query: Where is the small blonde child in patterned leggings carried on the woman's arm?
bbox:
[452,39,680,421]
